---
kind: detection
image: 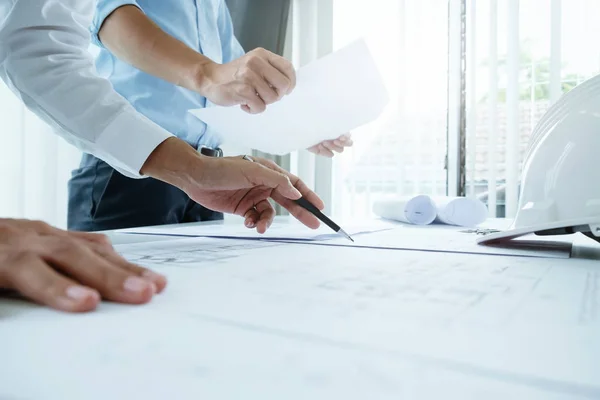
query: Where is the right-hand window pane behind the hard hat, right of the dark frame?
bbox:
[466,0,600,217]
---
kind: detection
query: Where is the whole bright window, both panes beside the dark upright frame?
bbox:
[333,0,600,217]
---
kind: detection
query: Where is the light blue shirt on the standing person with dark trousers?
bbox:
[91,0,244,147]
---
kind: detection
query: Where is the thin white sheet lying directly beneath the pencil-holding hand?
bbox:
[119,221,390,241]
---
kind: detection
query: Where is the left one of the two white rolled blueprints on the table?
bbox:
[373,195,437,225]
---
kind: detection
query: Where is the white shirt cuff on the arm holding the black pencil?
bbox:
[94,110,174,179]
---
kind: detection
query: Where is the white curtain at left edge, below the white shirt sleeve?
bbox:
[0,85,80,227]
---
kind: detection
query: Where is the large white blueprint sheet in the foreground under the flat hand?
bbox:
[0,239,600,400]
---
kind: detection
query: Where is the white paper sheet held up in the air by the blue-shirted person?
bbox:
[190,40,388,154]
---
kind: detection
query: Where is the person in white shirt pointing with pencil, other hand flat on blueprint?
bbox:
[0,0,324,311]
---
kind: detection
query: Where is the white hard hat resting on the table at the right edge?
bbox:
[477,75,600,243]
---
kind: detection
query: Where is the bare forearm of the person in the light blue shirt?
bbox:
[99,6,213,91]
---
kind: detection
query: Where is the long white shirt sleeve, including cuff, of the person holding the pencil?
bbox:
[0,0,172,178]
